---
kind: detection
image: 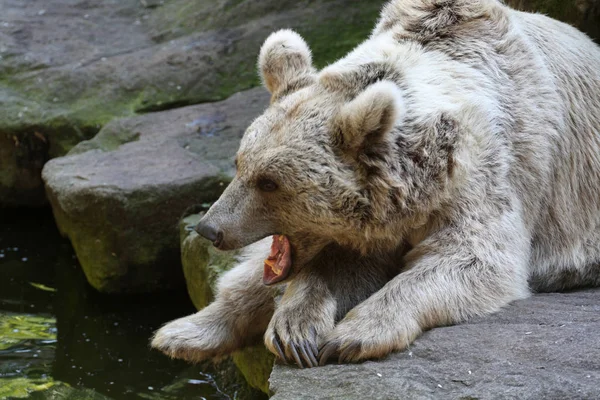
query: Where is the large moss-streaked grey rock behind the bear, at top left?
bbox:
[0,0,383,206]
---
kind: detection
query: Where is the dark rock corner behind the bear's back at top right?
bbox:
[506,0,600,42]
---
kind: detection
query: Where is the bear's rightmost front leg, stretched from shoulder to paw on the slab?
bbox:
[320,213,529,365]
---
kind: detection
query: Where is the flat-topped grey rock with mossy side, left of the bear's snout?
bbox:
[43,88,269,293]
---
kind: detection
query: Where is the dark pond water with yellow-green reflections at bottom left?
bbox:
[0,210,255,399]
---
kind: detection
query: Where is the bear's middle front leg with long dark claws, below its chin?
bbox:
[265,244,404,368]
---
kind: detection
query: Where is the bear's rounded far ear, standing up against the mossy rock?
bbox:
[258,29,315,100]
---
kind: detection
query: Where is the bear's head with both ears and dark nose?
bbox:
[197,30,454,282]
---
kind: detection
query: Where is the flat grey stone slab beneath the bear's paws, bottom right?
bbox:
[270,289,600,400]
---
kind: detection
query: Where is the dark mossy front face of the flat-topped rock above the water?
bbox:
[48,192,183,293]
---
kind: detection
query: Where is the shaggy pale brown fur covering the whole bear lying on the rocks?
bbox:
[152,0,600,366]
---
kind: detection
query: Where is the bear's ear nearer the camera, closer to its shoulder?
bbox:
[334,81,404,152]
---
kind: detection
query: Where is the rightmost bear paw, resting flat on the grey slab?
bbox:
[318,306,421,366]
